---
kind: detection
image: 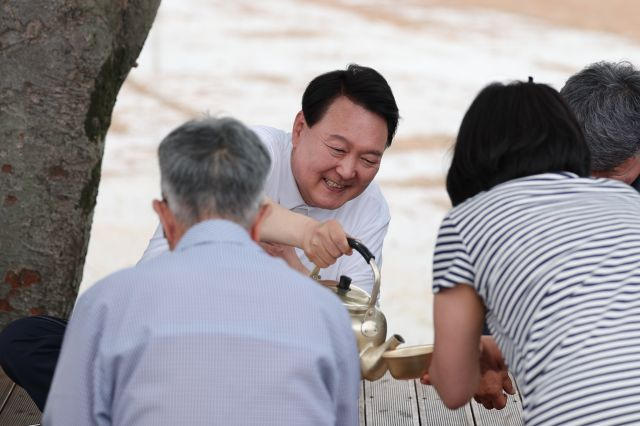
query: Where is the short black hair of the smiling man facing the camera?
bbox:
[302,64,399,147]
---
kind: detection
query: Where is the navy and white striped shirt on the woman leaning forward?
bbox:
[433,173,640,425]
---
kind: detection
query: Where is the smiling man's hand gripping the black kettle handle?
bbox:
[302,220,352,268]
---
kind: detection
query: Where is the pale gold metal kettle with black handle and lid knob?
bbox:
[311,238,404,381]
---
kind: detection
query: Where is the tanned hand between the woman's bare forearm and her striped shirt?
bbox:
[473,336,515,410]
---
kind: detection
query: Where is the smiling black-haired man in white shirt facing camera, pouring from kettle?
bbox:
[141,64,399,293]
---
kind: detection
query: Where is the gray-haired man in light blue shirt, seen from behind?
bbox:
[43,118,360,426]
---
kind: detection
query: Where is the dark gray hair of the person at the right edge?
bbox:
[560,62,640,172]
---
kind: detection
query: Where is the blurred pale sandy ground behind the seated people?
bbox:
[81,0,640,344]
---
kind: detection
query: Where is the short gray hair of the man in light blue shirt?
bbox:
[158,117,271,227]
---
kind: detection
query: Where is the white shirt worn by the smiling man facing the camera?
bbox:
[140,126,391,293]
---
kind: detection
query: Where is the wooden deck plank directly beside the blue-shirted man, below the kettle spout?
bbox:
[364,372,420,426]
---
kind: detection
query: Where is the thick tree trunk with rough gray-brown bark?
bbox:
[0,0,160,328]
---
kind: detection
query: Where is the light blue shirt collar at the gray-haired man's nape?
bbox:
[175,219,251,251]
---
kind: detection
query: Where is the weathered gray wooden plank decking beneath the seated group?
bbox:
[0,369,523,426]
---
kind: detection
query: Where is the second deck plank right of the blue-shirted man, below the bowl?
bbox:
[414,380,474,426]
